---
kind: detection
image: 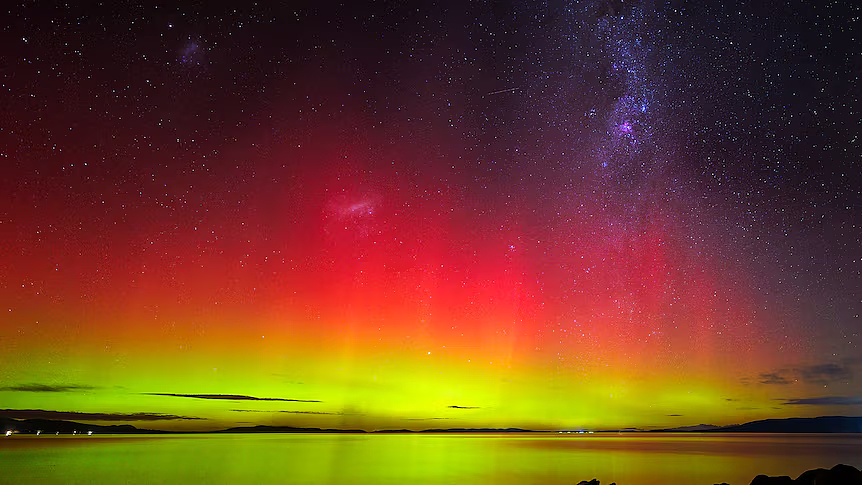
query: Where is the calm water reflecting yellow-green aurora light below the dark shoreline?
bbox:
[0,433,862,485]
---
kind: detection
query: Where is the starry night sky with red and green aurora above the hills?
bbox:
[0,0,862,430]
